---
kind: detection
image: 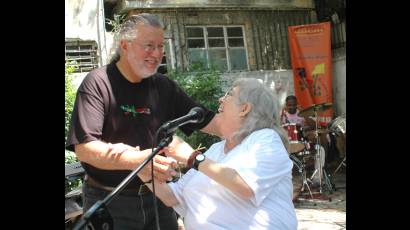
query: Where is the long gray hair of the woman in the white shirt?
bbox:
[232,78,288,148]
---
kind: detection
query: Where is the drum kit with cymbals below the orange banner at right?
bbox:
[282,103,346,198]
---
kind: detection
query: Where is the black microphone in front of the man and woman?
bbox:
[159,107,205,136]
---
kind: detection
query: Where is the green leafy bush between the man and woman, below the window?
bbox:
[168,64,224,151]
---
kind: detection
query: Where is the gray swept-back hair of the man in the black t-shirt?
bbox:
[110,13,163,63]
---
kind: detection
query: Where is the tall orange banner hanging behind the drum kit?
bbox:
[288,22,333,126]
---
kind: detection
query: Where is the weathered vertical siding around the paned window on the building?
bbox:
[129,9,317,71]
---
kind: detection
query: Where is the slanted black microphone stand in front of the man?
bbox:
[73,132,173,230]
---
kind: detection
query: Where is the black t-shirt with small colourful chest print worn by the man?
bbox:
[66,63,215,188]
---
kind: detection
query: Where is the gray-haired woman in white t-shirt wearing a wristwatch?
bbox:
[141,79,297,230]
